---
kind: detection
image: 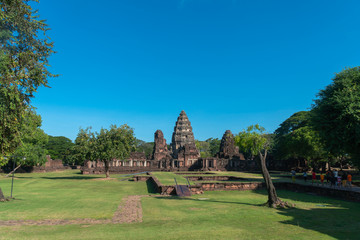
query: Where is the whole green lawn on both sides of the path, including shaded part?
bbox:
[0,171,360,239]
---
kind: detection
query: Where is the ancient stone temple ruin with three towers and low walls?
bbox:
[81,111,247,174]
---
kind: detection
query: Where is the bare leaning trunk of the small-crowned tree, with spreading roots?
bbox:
[259,150,292,208]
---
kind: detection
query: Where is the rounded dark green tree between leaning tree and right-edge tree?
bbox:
[274,111,329,170]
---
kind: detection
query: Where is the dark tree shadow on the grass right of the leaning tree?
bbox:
[253,190,360,239]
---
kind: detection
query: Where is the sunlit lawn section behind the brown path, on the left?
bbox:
[0,170,147,220]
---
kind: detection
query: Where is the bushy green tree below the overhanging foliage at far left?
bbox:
[10,109,48,166]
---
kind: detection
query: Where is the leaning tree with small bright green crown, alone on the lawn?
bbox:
[235,124,290,208]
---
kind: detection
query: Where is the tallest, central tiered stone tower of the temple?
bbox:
[171,110,200,160]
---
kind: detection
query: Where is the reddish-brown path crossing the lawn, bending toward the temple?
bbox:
[0,195,152,227]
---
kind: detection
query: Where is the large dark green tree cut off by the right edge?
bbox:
[312,67,360,167]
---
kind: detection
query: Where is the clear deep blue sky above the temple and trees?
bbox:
[33,0,360,143]
